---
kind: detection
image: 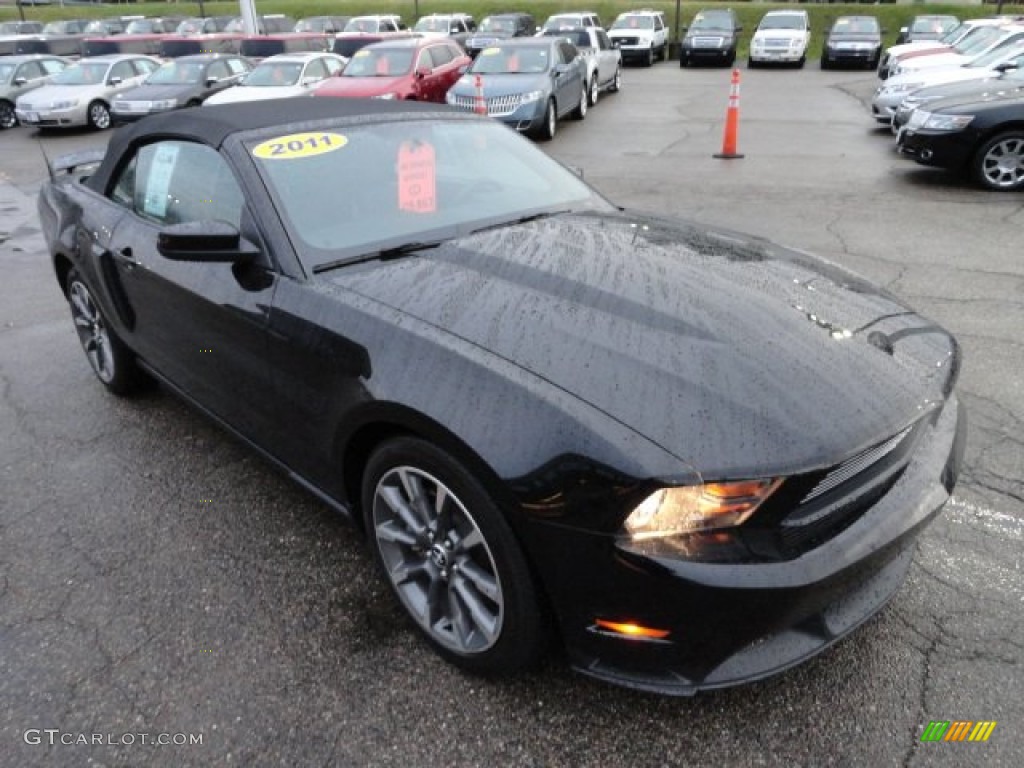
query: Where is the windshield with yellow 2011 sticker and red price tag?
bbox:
[247,118,614,270]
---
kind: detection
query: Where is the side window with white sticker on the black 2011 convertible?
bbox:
[120,141,245,226]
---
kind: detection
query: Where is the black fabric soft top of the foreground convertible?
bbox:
[88,97,454,191]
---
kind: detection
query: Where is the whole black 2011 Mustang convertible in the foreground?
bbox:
[39,99,965,693]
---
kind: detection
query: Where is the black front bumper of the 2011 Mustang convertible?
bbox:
[529,396,966,695]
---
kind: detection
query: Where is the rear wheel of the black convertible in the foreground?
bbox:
[67,269,144,395]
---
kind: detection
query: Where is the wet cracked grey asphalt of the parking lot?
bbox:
[0,61,1024,766]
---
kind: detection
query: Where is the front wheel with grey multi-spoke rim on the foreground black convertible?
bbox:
[362,437,544,674]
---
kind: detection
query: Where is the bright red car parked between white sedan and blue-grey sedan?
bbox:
[313,38,472,103]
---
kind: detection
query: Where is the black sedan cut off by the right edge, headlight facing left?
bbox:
[896,88,1024,191]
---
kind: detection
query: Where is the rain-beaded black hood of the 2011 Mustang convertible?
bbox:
[322,214,958,477]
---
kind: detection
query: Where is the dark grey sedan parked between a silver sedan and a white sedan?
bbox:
[111,53,253,123]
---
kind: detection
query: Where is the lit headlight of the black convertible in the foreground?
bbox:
[624,478,782,541]
